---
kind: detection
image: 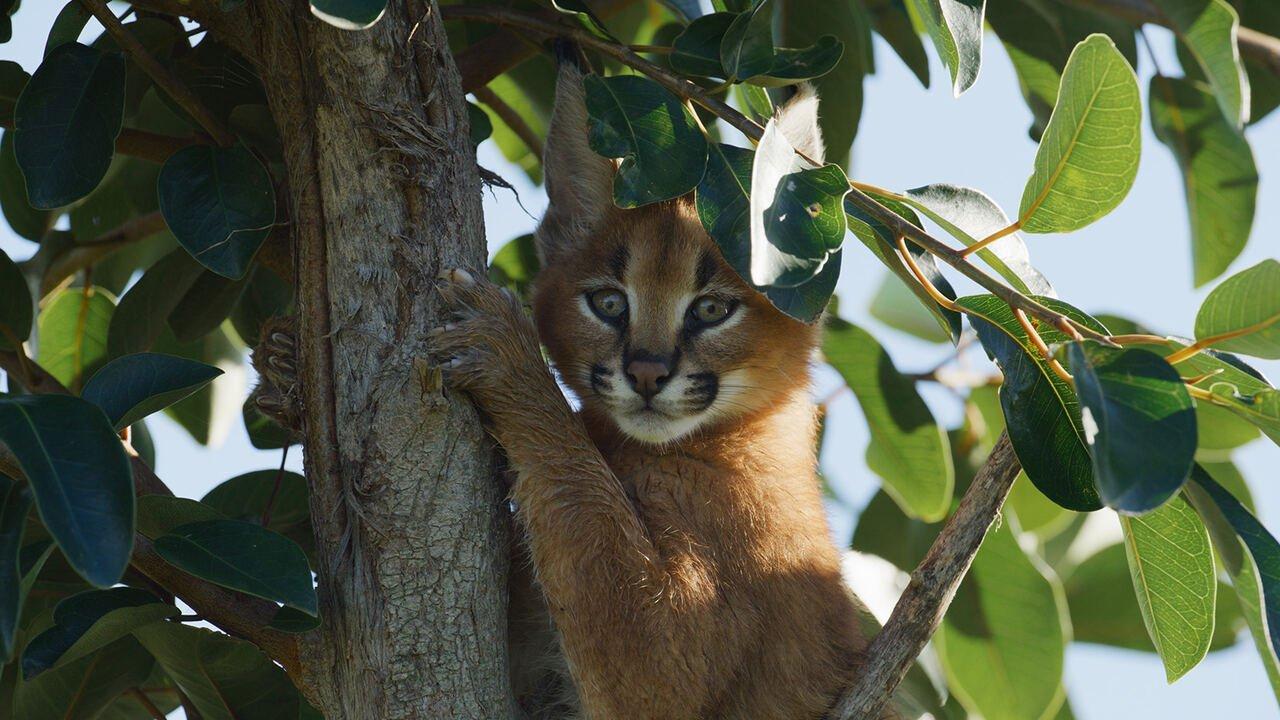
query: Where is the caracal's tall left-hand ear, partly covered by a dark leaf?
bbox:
[535,45,613,264]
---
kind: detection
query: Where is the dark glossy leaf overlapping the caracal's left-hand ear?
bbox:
[584,76,707,208]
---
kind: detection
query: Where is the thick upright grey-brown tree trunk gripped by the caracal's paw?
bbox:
[247,0,511,720]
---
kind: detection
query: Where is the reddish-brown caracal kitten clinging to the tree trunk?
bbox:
[435,64,880,720]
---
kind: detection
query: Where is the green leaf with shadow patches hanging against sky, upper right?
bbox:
[1148,76,1258,287]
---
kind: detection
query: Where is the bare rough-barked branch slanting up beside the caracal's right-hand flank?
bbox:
[831,433,1021,720]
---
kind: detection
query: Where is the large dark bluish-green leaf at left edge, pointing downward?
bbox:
[0,395,133,587]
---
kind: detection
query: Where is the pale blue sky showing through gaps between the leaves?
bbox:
[0,0,1280,720]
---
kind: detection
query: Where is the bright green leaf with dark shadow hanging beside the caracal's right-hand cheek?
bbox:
[822,318,955,521]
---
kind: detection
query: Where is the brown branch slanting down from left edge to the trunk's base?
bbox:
[0,350,301,678]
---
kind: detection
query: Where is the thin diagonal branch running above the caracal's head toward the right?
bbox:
[440,5,1110,343]
